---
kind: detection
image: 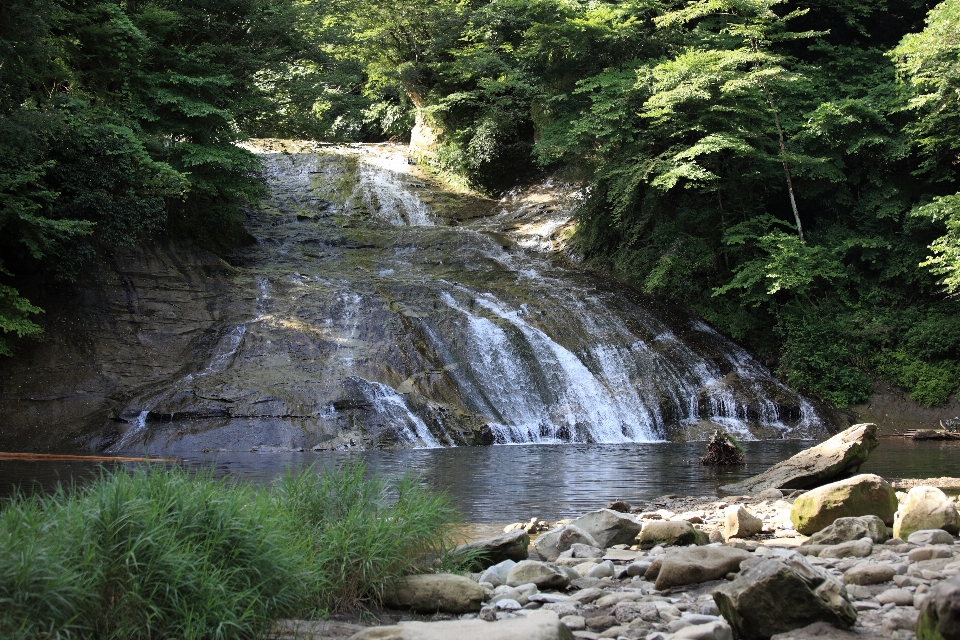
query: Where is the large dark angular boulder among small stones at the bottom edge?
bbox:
[713,554,857,640]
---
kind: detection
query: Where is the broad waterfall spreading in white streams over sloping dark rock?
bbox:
[101,141,826,452]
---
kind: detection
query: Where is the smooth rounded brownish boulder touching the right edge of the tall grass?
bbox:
[383,573,485,613]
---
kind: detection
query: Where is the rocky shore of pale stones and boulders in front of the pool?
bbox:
[278,425,960,640]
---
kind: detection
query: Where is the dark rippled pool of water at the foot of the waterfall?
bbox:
[0,440,960,524]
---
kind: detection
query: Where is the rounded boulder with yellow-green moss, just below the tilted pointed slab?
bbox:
[790,473,897,540]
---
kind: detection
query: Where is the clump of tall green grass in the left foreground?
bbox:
[0,464,464,640]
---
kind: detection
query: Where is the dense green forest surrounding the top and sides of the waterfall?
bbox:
[0,0,960,407]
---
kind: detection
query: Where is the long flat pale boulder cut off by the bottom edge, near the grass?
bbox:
[349,611,573,640]
